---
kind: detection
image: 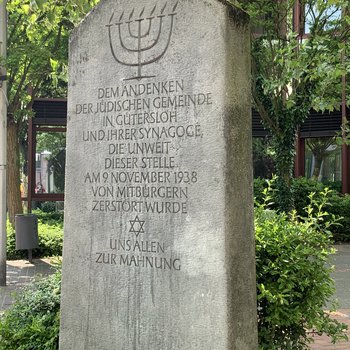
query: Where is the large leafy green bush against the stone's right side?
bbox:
[255,186,346,350]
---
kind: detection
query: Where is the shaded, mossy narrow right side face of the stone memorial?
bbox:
[223,6,258,350]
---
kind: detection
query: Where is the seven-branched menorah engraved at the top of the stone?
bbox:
[106,2,178,80]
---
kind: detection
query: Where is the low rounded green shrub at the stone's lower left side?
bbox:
[0,271,61,350]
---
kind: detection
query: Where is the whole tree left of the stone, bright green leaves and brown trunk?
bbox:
[6,0,97,223]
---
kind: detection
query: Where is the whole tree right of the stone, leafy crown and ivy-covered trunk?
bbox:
[238,0,350,210]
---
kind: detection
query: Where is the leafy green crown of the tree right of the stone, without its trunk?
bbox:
[245,0,350,113]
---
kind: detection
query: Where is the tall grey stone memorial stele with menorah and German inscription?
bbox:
[60,0,257,350]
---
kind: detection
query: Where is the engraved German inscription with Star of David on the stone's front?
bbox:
[80,79,213,271]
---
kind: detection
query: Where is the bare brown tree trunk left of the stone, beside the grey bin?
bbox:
[7,118,23,226]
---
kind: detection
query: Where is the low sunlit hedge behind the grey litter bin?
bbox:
[7,218,63,260]
